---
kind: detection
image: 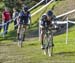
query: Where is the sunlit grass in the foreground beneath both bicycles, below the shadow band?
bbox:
[0,27,75,63]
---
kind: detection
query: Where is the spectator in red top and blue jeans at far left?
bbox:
[2,7,11,34]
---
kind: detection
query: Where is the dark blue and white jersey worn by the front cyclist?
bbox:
[39,14,58,28]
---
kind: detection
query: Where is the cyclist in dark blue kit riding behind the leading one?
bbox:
[17,6,31,41]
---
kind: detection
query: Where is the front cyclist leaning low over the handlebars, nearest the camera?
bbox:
[40,10,54,49]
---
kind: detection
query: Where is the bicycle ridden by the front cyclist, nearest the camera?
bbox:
[43,28,54,56]
